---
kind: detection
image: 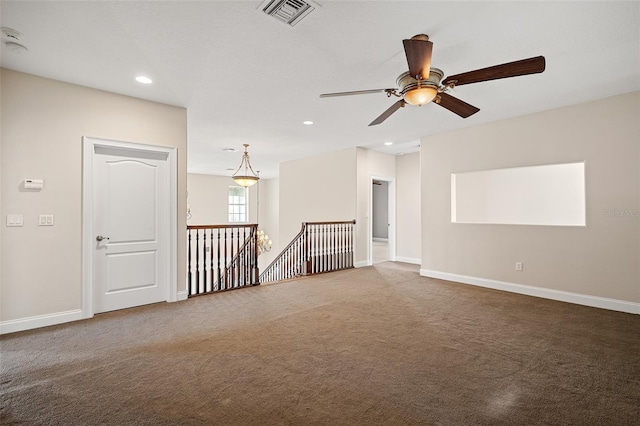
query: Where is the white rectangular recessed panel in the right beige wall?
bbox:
[451,162,586,226]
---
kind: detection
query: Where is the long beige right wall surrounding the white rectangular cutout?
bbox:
[421,92,640,310]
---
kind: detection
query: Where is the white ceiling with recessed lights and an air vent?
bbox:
[0,0,640,178]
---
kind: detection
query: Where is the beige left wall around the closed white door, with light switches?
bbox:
[0,69,187,321]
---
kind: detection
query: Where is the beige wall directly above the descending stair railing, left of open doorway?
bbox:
[279,148,357,249]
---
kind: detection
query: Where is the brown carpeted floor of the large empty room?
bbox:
[0,262,640,425]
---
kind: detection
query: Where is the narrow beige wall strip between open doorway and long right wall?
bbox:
[396,152,421,264]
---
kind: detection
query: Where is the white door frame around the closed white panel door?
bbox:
[82,136,178,318]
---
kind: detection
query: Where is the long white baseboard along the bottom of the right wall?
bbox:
[420,269,640,314]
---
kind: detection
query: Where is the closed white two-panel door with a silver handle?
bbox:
[92,146,170,313]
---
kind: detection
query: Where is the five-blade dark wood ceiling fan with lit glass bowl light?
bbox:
[320,34,545,126]
